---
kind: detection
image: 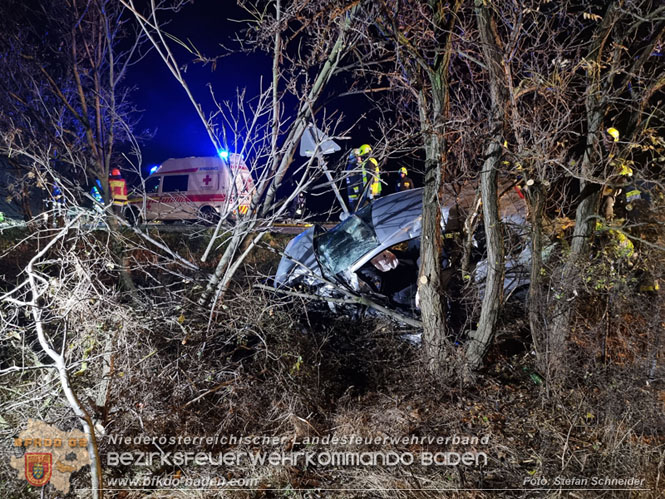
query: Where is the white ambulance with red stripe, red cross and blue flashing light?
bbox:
[128,154,254,223]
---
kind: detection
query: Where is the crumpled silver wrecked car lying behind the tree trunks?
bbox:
[274,185,530,316]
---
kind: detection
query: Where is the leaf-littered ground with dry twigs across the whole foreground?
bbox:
[2,229,665,498]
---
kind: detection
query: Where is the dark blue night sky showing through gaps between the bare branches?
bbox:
[127,0,404,207]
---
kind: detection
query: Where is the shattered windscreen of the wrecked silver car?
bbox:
[315,206,379,275]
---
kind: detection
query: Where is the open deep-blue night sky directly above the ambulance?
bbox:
[127,0,270,167]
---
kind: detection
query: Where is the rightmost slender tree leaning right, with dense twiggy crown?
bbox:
[548,1,665,371]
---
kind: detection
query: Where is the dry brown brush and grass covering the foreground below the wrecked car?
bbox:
[0,225,665,498]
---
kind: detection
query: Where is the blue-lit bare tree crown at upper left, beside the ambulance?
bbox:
[1,0,146,207]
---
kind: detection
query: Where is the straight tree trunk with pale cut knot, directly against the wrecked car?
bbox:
[356,0,462,372]
